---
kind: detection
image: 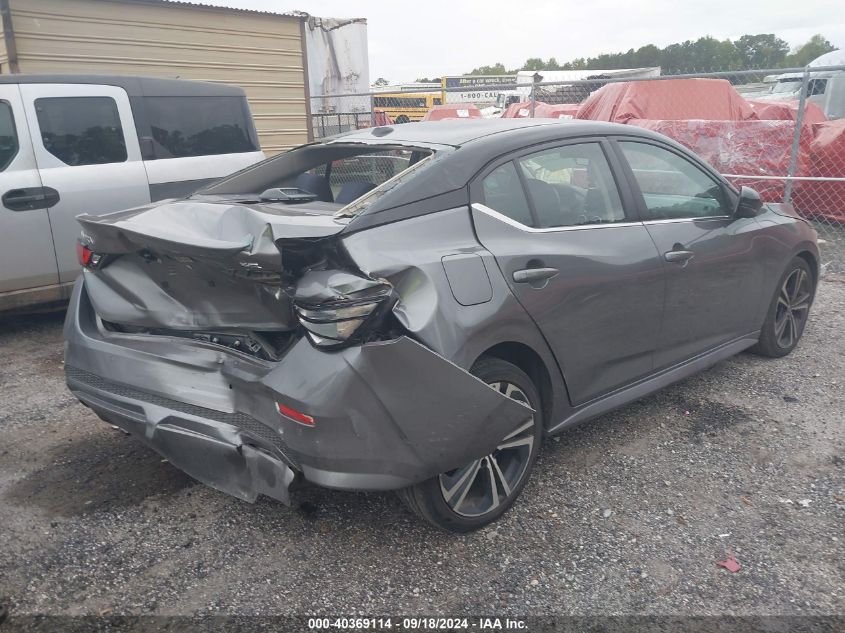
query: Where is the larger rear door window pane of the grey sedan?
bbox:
[517,143,625,228]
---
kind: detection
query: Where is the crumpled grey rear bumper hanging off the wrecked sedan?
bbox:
[65,275,532,503]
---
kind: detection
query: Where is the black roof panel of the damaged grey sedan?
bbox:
[332,118,653,147]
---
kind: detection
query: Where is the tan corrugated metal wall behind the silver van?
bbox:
[2,0,308,154]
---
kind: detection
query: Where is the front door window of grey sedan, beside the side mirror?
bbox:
[619,141,730,220]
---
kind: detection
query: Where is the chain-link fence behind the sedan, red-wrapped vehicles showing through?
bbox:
[311,66,845,273]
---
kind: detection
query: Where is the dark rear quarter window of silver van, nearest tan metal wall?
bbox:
[144,97,258,158]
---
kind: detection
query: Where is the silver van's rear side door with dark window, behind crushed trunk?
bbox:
[20,84,150,283]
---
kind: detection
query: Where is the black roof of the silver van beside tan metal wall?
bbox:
[0,74,245,97]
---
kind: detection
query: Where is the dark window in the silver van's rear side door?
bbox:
[35,97,126,167]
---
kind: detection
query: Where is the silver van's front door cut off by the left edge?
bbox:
[0,84,61,310]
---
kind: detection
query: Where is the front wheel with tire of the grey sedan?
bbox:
[751,257,816,358]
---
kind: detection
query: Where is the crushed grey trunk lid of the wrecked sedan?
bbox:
[77,196,347,331]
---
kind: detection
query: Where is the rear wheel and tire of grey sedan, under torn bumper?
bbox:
[397,357,543,533]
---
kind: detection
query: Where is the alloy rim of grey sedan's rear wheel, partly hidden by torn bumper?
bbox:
[440,381,535,517]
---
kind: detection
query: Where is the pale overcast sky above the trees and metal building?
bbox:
[201,0,845,84]
